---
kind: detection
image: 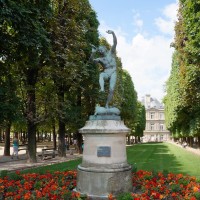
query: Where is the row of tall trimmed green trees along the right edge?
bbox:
[164,0,200,147]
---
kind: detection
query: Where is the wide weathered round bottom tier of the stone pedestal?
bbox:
[76,165,132,199]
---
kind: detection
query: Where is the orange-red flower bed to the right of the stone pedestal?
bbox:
[131,170,200,200]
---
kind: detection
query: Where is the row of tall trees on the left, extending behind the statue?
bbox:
[0,0,145,162]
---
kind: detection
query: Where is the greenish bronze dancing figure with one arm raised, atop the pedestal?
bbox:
[90,30,117,108]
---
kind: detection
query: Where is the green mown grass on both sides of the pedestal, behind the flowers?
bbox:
[18,143,200,178]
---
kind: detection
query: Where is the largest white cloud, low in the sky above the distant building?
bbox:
[118,34,172,99]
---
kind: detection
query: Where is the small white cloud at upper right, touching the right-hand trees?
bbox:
[155,3,178,35]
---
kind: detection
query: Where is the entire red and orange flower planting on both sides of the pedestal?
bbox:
[0,170,200,200]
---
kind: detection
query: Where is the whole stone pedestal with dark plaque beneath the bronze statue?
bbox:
[76,120,132,199]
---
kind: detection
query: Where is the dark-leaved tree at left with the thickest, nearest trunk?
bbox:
[1,0,51,162]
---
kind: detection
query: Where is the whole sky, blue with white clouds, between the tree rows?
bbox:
[90,0,178,100]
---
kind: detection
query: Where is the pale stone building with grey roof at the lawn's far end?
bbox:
[142,95,170,142]
